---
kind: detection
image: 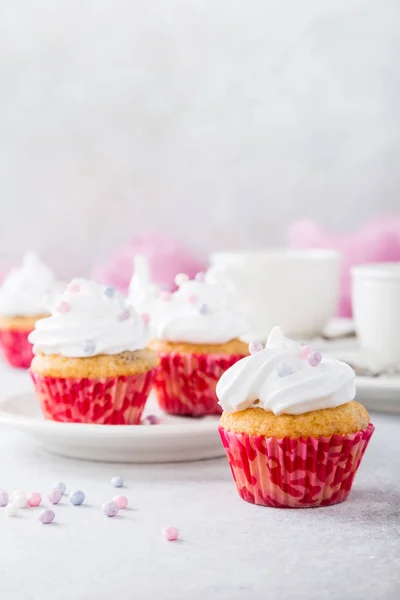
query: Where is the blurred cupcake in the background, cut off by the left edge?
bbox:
[0,253,56,369]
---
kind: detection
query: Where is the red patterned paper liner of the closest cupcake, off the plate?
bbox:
[219,423,375,508]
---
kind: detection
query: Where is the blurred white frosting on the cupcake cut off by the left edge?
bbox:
[0,252,56,317]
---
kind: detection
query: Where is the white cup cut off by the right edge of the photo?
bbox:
[351,263,400,370]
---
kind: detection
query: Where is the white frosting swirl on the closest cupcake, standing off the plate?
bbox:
[216,327,356,415]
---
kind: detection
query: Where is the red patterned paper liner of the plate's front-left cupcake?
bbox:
[30,369,155,425]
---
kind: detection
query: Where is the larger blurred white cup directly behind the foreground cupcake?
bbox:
[206,249,340,341]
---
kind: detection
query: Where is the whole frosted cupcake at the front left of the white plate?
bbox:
[29,279,158,425]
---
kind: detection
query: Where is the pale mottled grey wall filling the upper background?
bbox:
[0,0,400,275]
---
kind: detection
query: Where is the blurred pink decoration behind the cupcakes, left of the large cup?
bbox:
[92,234,207,294]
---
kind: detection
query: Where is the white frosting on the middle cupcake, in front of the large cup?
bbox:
[151,273,249,344]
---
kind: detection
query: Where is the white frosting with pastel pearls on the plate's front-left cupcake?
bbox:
[29,279,149,358]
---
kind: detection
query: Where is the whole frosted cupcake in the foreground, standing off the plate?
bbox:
[217,327,374,508]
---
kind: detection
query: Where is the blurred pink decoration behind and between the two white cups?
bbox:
[289,216,400,317]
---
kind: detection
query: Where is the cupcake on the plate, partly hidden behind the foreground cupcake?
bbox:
[150,274,248,417]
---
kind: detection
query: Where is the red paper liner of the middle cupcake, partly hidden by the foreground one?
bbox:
[154,352,243,417]
